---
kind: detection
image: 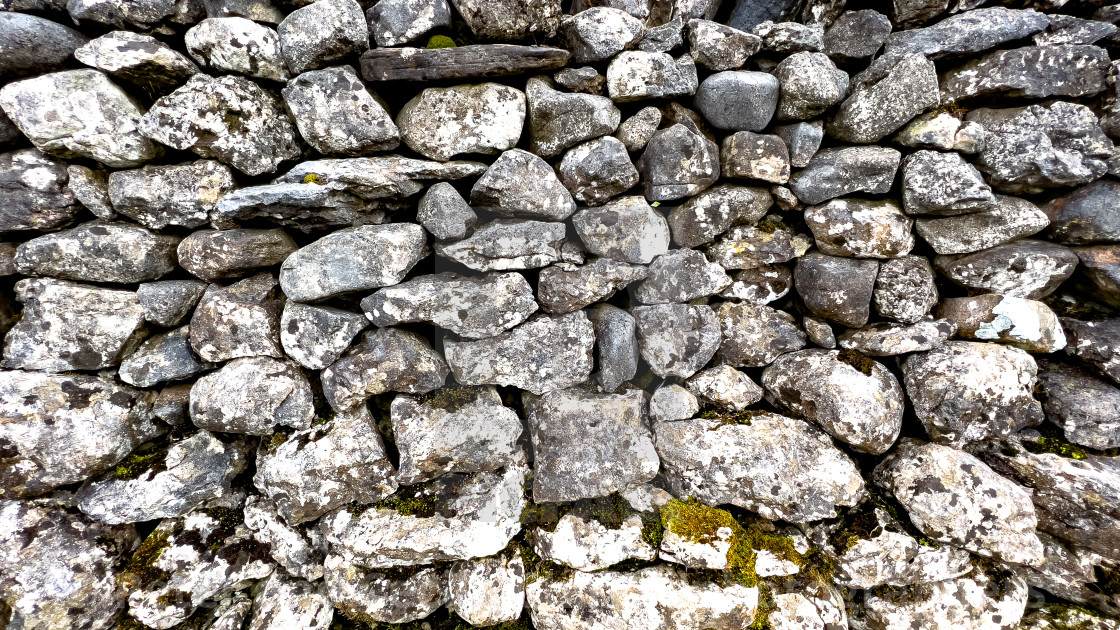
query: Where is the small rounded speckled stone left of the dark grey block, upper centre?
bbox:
[558,136,638,205]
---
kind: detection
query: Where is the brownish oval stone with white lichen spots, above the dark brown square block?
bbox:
[804,198,914,259]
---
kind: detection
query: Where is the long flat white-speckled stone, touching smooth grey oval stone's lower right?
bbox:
[362,272,536,339]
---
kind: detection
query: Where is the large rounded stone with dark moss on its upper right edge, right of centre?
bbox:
[762,350,906,455]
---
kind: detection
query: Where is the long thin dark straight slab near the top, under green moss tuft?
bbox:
[362,44,570,81]
